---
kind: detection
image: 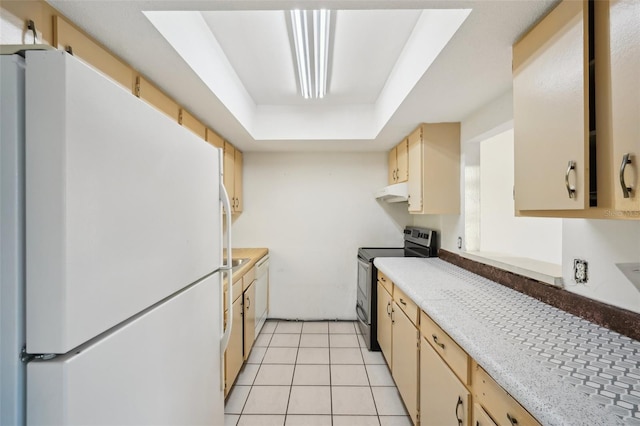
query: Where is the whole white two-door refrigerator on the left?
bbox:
[0,51,231,425]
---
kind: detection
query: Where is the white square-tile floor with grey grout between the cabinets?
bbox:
[225,320,411,426]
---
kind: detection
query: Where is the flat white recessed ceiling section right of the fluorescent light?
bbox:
[328,9,421,104]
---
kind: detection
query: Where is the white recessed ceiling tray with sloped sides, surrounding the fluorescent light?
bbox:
[145,9,470,140]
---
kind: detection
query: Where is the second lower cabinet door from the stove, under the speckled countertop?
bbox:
[391,302,420,425]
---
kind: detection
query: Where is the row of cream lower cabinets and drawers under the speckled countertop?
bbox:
[377,271,540,426]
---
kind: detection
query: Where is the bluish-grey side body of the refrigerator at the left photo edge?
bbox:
[0,55,25,425]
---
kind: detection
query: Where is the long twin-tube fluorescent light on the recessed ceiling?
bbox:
[291,9,331,99]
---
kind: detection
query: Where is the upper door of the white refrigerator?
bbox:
[26,51,222,354]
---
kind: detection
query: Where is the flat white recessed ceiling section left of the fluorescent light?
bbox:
[202,10,299,104]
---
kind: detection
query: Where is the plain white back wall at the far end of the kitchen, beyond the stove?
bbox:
[233,152,410,319]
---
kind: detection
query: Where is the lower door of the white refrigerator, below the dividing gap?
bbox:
[27,274,224,426]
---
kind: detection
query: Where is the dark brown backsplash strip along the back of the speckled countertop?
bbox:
[438,249,640,340]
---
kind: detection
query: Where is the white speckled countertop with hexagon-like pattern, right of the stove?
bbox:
[374,258,640,426]
